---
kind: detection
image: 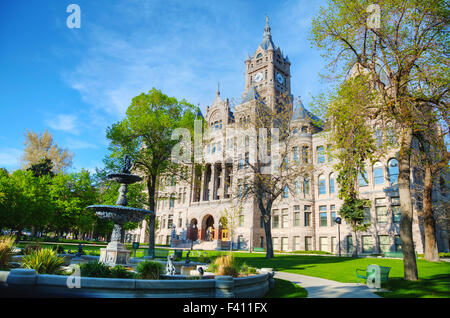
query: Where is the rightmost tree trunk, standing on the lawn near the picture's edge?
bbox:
[423,167,440,262]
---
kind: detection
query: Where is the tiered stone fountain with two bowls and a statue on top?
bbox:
[87,155,155,266]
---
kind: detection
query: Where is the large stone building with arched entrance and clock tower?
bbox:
[126,20,449,254]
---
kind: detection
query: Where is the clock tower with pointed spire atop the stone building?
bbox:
[243,17,291,108]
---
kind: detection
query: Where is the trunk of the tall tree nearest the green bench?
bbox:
[398,128,418,281]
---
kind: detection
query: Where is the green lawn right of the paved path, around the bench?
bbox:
[187,251,450,298]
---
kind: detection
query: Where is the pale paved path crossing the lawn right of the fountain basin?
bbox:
[274,272,381,298]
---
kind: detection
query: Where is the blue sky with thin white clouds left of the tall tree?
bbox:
[0,0,325,171]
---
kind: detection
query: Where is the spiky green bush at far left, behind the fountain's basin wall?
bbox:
[21,248,64,274]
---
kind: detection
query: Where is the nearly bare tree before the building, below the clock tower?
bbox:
[227,95,315,258]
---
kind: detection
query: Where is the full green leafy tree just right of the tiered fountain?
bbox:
[107,88,194,256]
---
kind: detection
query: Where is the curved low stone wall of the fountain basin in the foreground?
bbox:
[0,268,274,298]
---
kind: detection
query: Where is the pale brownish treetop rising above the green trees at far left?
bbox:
[22,129,73,173]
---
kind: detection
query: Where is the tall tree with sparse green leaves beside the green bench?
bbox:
[311,0,450,280]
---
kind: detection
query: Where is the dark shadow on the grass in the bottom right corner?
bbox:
[377,274,450,298]
